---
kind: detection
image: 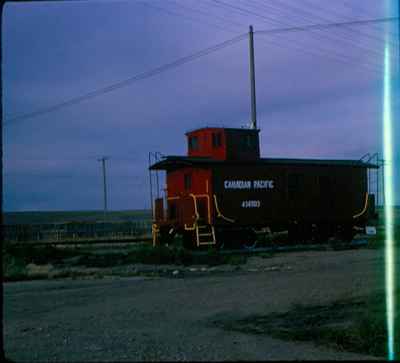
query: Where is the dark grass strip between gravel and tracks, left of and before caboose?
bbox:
[3,244,247,281]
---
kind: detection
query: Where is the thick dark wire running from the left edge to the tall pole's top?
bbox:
[4,33,247,124]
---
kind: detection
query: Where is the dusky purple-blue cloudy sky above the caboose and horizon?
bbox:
[2,0,400,211]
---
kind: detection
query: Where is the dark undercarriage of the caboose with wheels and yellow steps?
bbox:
[152,191,373,249]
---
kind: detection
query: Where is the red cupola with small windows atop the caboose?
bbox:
[186,127,260,160]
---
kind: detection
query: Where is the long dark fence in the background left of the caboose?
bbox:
[3,220,152,242]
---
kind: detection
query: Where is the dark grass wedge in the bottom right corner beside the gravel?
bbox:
[219,294,400,357]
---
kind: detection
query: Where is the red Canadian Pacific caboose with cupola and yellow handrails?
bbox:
[150,127,376,247]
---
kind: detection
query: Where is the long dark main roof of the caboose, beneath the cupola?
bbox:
[149,155,379,170]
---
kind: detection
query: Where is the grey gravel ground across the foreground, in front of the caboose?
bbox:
[3,249,390,361]
